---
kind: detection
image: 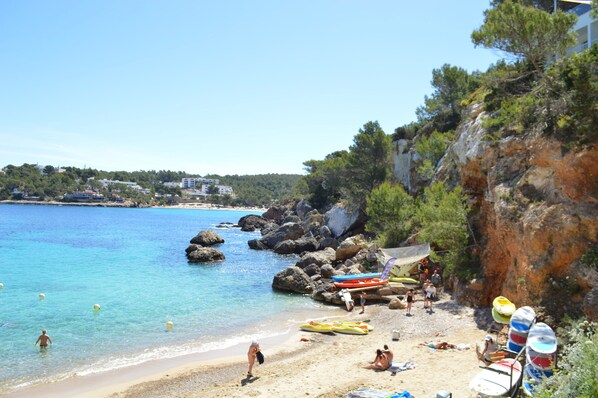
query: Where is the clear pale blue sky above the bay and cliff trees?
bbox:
[0,0,499,175]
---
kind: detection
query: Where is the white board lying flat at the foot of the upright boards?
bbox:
[469,358,521,397]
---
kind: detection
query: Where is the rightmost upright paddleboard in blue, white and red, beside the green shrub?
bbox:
[522,322,557,397]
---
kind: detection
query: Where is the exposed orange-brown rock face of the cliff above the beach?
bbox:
[435,106,598,317]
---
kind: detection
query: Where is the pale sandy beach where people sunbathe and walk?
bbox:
[6,297,486,398]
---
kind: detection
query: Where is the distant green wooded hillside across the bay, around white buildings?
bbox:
[0,164,301,207]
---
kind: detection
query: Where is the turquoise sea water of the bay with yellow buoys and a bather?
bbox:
[0,205,315,393]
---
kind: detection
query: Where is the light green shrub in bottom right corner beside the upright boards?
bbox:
[534,321,598,398]
